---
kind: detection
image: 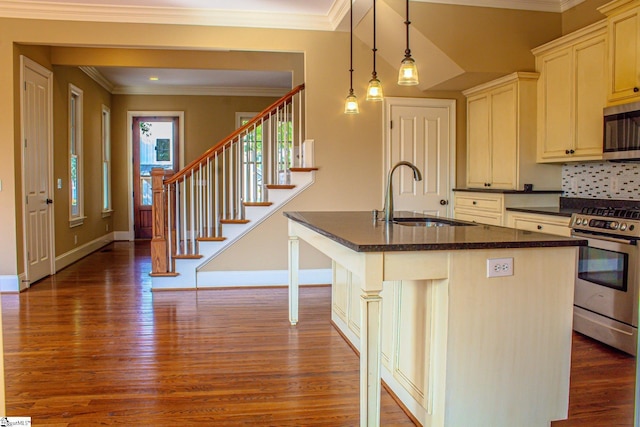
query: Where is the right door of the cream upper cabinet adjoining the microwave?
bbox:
[573,37,607,160]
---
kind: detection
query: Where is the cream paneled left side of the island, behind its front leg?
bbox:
[331,261,434,420]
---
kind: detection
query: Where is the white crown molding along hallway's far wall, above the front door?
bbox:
[111,85,291,98]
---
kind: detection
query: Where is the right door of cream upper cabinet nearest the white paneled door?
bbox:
[490,83,518,190]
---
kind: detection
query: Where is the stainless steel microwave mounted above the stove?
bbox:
[603,102,640,160]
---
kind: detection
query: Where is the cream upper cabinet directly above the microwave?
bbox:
[598,0,640,105]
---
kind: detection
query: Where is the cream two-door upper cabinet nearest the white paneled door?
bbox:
[463,72,561,190]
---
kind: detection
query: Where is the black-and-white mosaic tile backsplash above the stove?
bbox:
[562,161,640,200]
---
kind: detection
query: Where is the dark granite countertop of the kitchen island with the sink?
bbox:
[284,212,587,252]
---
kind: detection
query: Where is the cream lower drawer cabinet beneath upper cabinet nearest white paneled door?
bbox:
[453,191,560,226]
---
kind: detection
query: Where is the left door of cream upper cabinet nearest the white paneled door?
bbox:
[467,95,490,188]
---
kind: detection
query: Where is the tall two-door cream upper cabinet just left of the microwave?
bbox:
[533,20,607,162]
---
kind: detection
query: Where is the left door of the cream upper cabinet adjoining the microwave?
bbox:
[538,48,572,161]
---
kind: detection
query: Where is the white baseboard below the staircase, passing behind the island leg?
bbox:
[196,268,332,288]
